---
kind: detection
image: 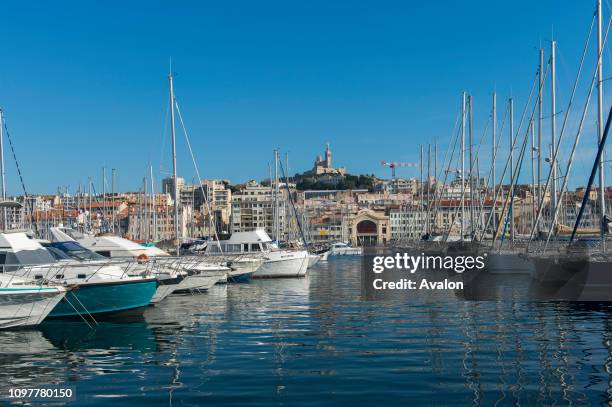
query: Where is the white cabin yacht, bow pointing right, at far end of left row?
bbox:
[221,229,308,278]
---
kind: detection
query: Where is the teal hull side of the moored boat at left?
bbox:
[47,279,157,318]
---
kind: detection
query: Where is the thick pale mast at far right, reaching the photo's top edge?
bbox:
[597,0,606,251]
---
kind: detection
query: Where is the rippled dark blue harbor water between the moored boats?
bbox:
[0,256,612,407]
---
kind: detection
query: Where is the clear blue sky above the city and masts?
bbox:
[0,0,612,193]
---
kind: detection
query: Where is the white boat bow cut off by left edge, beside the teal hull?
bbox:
[0,273,66,329]
